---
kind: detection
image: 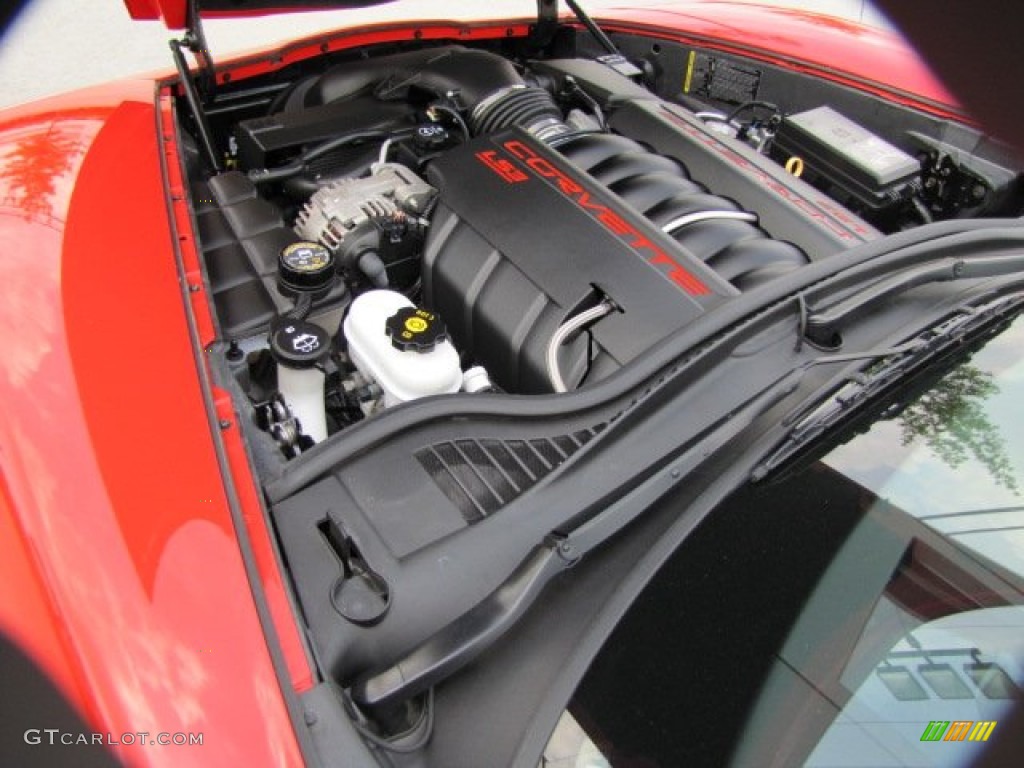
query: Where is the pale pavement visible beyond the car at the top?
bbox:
[0,0,885,108]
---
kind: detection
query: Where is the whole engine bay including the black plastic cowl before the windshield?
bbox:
[155,13,1024,764]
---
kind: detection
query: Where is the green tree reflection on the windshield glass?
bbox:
[899,365,1018,493]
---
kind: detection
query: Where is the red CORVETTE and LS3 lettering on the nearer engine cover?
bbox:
[495,139,711,296]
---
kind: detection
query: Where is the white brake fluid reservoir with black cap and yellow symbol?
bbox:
[344,291,462,408]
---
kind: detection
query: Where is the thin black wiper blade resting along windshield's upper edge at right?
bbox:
[751,293,1024,482]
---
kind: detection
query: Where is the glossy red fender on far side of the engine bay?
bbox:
[600,0,967,120]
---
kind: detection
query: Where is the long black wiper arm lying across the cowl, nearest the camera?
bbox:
[349,371,804,710]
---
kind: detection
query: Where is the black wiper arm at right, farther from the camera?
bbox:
[804,253,1024,346]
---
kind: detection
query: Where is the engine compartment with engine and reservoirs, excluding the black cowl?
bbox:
[179,30,1022,460]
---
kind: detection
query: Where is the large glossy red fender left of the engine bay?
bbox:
[0,82,301,765]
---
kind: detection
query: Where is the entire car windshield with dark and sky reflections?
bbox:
[543,318,1024,768]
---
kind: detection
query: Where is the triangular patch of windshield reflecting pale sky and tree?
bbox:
[824,313,1024,574]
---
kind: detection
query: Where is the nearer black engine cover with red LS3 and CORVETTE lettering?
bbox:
[423,130,737,393]
